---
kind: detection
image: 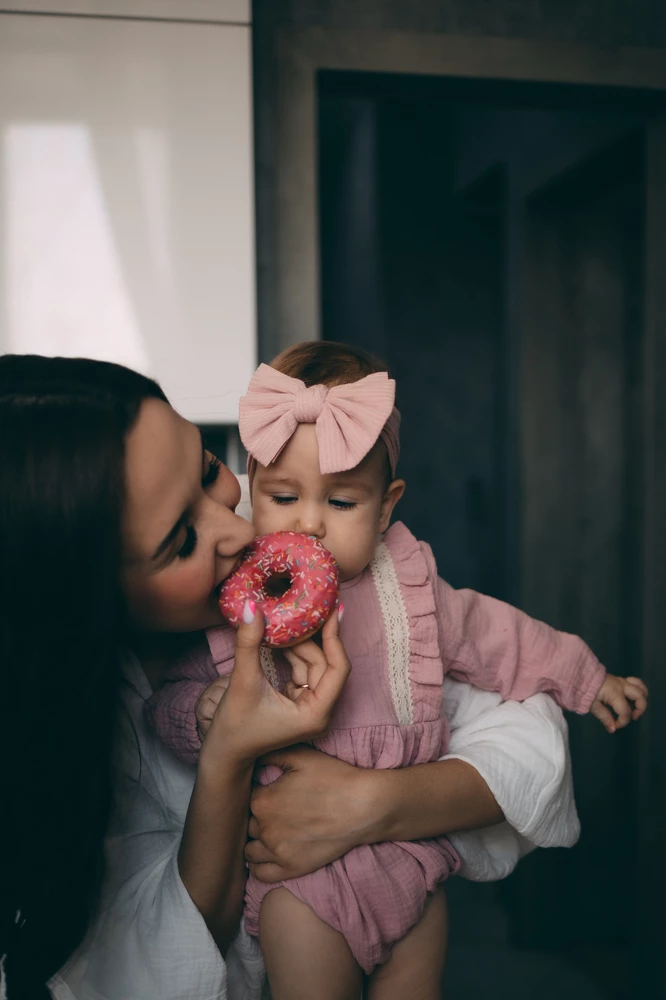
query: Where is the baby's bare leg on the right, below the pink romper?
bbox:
[366,888,449,1000]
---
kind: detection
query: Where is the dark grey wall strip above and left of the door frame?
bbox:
[253,0,666,360]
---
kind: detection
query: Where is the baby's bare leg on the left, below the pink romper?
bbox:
[259,888,362,1000]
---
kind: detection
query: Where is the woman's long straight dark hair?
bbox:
[0,355,165,1000]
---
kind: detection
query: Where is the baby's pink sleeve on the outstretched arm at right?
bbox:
[436,578,606,715]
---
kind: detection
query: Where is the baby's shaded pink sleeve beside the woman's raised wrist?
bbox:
[146,644,218,764]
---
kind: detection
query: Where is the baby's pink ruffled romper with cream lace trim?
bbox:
[149,523,604,973]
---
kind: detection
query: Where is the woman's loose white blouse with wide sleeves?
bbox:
[42,477,580,1000]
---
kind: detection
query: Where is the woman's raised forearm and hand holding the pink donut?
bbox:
[178,609,349,954]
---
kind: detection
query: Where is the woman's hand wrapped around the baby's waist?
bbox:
[245,747,370,882]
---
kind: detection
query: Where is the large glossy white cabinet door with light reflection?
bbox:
[0,6,256,423]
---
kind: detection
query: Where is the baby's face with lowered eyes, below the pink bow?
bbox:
[252,424,404,581]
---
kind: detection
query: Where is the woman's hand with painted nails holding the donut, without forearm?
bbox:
[199,602,350,768]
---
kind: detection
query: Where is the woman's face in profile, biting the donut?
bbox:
[123,399,254,632]
